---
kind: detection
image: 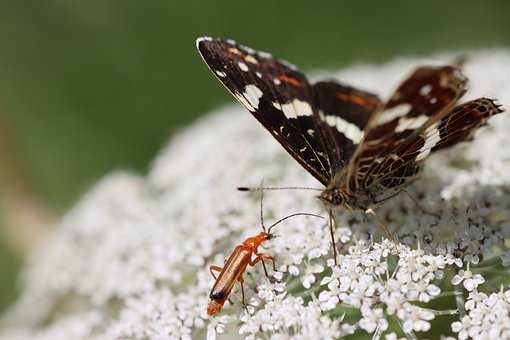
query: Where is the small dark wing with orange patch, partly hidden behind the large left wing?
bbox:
[313,80,381,173]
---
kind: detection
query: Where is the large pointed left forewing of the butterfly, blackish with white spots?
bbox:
[197,38,332,185]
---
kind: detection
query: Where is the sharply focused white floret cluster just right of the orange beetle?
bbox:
[319,240,455,333]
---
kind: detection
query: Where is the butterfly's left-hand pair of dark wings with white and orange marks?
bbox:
[197,38,381,185]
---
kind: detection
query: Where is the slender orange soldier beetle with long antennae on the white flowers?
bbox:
[207,191,323,316]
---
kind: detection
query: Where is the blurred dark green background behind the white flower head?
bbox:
[0,0,510,310]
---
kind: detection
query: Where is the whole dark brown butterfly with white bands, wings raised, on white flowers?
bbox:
[197,37,503,259]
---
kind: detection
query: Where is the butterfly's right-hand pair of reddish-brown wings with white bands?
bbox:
[349,66,502,197]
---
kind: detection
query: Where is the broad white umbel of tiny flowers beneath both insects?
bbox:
[0,50,510,340]
